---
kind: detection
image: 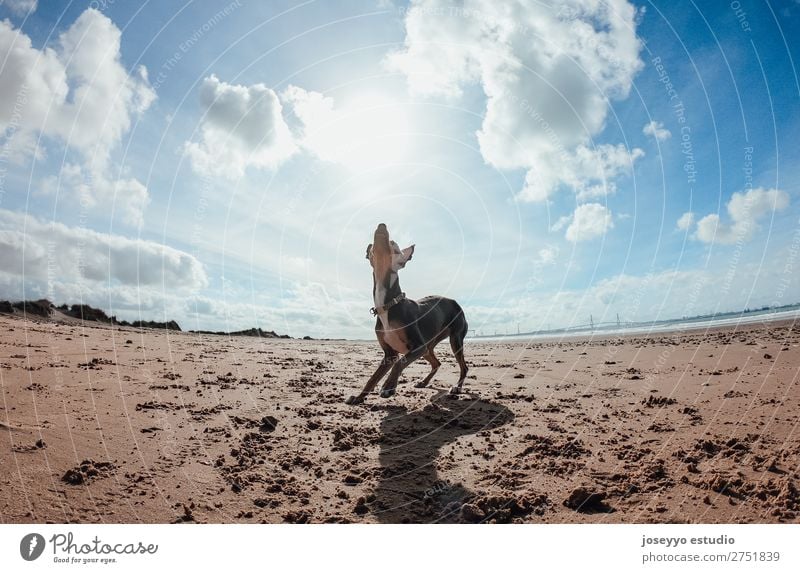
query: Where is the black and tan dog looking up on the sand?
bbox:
[347,223,467,404]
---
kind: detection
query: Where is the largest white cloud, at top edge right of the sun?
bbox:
[387,0,643,201]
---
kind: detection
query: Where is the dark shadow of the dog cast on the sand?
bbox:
[370,392,514,523]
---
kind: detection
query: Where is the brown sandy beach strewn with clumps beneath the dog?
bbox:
[0,316,800,523]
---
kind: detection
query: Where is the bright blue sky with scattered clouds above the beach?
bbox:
[0,0,800,338]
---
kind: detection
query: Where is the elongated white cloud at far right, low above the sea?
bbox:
[692,188,789,245]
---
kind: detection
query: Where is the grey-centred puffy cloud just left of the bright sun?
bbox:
[184,75,297,178]
